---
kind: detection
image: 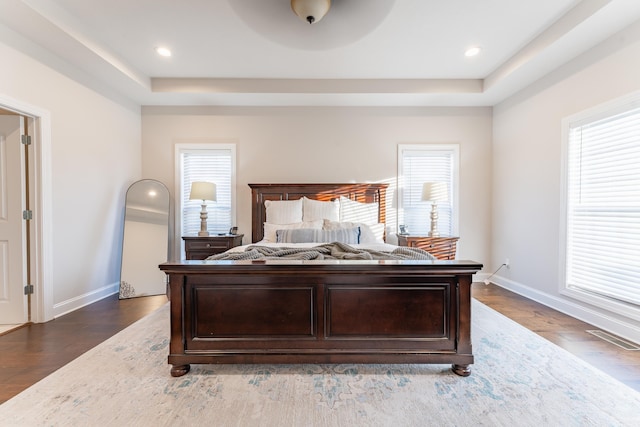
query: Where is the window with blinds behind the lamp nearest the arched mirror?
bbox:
[176,144,236,236]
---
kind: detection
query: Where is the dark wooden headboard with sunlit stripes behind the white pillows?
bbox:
[249,184,389,243]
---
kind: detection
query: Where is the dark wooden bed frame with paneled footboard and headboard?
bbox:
[160,184,482,377]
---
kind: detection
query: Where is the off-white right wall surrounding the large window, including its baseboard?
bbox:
[491,23,640,342]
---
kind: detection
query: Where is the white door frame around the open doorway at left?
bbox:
[0,94,54,323]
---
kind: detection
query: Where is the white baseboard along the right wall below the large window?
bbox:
[491,276,640,344]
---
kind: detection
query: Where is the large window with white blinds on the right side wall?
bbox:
[561,95,640,316]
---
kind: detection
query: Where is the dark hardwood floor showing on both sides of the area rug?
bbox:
[0,284,640,403]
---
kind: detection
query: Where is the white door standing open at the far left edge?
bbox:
[0,115,28,324]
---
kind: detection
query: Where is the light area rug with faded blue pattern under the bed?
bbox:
[0,300,640,427]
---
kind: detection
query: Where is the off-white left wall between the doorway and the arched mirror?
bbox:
[0,43,141,315]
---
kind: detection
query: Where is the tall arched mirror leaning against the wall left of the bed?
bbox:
[120,179,170,299]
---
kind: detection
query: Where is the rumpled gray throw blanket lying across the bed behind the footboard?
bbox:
[207,242,436,261]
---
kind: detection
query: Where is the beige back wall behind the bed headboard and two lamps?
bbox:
[142,107,492,263]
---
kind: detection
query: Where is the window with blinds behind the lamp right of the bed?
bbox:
[398,144,460,236]
